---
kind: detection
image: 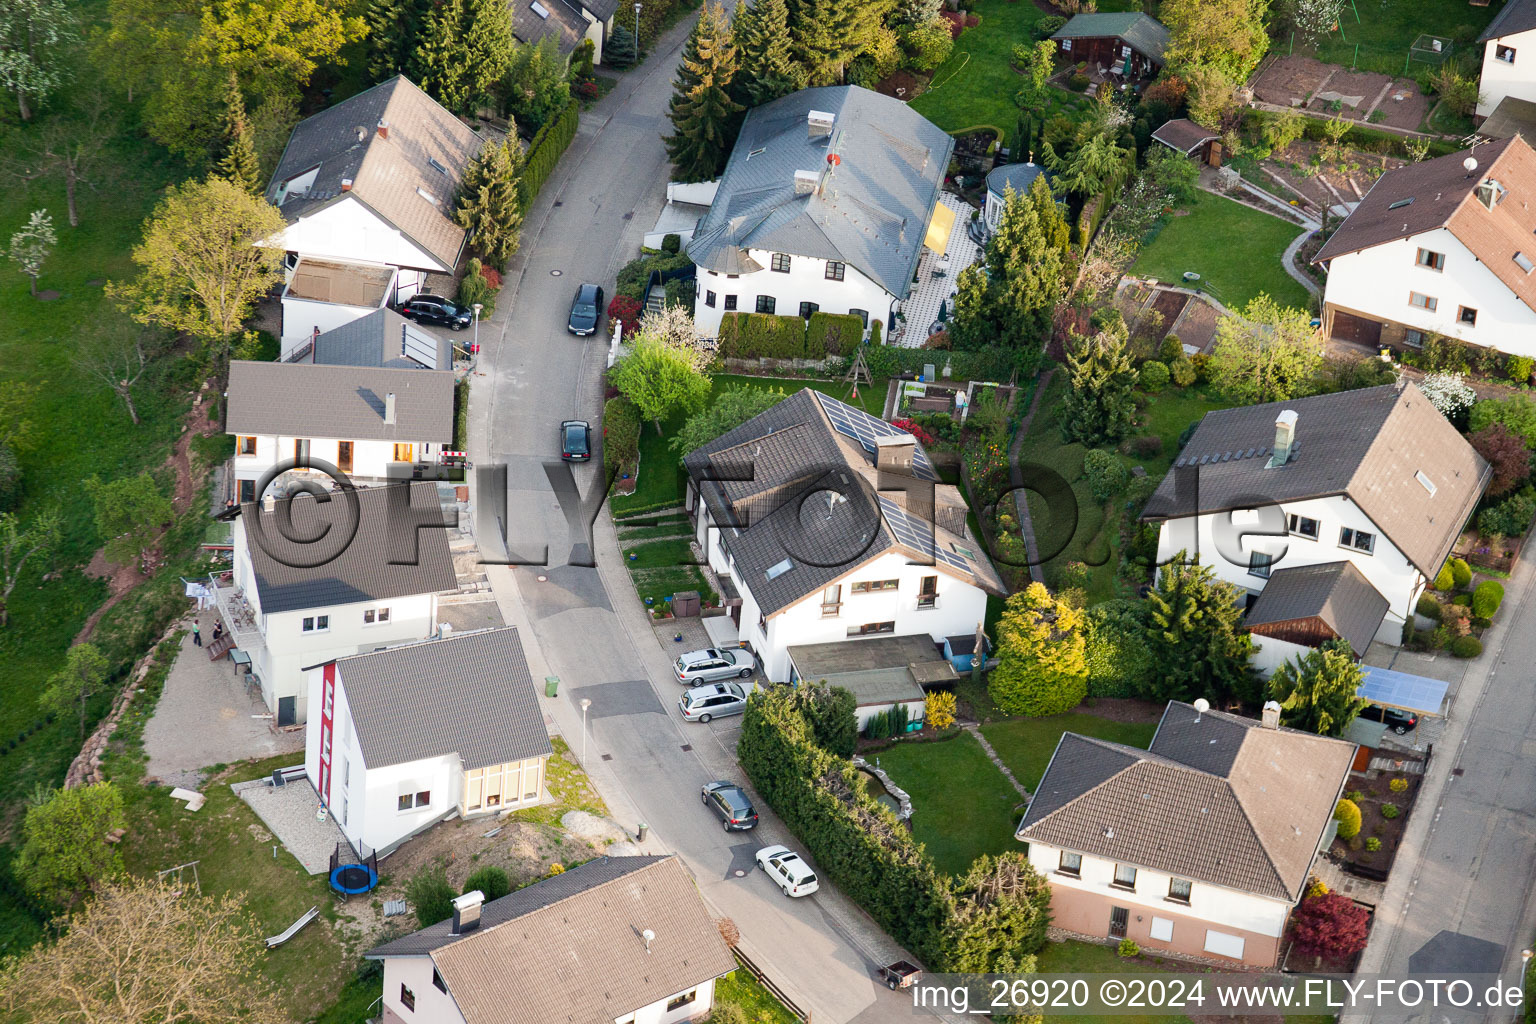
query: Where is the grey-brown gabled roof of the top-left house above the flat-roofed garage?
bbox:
[267,75,482,270]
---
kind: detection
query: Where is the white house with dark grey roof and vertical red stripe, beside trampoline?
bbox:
[304,626,551,851]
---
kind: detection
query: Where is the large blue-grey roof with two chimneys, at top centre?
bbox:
[688,86,954,298]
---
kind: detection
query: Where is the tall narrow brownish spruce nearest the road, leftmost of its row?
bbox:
[665,3,742,181]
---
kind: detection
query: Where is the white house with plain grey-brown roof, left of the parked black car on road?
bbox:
[224,359,453,502]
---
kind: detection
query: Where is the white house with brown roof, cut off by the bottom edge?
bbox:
[364,857,736,1024]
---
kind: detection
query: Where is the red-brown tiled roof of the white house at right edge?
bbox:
[1313,135,1536,316]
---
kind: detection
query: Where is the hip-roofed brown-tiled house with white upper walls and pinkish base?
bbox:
[1017,702,1355,967]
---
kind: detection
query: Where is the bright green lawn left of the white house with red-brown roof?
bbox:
[1134,192,1312,309]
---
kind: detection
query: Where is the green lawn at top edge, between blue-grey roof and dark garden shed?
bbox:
[912,0,1064,140]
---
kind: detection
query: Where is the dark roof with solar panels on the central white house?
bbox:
[684,388,1006,616]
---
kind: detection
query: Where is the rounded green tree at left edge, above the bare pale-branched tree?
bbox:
[15,779,126,902]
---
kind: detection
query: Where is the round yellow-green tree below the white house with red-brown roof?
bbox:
[1210,293,1322,405]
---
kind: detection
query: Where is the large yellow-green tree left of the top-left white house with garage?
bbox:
[108,177,284,355]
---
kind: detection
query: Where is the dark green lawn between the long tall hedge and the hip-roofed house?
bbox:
[869,732,1023,875]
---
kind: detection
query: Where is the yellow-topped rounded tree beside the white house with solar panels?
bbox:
[988,583,1087,715]
